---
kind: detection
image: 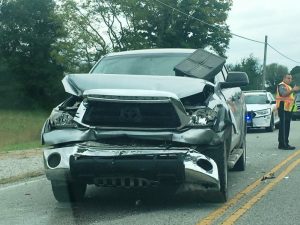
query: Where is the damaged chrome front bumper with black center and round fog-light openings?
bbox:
[44,144,220,190]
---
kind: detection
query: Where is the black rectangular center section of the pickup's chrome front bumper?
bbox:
[70,154,185,185]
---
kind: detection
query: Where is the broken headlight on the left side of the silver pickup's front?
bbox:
[49,111,77,128]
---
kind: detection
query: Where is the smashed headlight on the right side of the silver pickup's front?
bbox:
[190,107,219,126]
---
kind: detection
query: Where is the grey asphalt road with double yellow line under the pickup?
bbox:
[0,121,300,225]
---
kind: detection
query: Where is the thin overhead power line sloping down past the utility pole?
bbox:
[154,0,300,64]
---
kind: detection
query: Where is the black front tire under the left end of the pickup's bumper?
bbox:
[51,181,87,202]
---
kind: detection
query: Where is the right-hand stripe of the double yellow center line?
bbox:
[222,159,300,225]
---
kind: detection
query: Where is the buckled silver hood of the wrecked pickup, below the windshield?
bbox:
[62,74,213,98]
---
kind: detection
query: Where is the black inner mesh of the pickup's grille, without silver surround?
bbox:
[82,101,180,128]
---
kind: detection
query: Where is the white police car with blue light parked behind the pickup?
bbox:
[244,90,279,132]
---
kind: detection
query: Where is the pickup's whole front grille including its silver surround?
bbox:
[74,89,190,129]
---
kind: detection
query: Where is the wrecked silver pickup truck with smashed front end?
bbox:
[41,49,249,202]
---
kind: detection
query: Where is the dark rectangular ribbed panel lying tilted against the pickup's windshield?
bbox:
[174,49,226,82]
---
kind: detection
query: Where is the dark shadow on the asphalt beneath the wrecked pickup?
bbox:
[50,186,219,224]
